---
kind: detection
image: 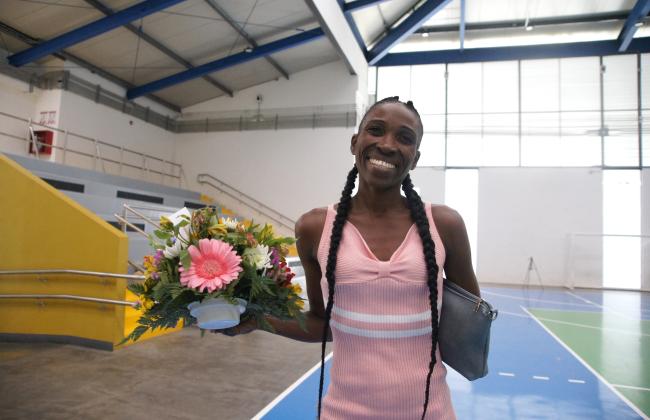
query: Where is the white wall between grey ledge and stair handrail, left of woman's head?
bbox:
[176,128,353,220]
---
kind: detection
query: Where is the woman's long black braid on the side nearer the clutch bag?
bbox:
[402,175,439,420]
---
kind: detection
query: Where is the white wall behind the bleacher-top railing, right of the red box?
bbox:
[57,91,178,186]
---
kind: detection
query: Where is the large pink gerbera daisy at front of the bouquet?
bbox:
[179,239,242,292]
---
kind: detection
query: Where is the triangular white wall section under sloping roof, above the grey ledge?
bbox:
[183,61,360,114]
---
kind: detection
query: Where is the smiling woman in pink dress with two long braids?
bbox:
[220,97,480,420]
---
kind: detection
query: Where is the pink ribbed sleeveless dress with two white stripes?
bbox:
[318,204,456,420]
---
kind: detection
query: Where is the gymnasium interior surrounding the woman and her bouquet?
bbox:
[0,0,650,420]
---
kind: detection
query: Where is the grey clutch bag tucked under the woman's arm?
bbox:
[438,279,499,381]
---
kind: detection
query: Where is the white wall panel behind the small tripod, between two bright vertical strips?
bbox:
[477,168,603,286]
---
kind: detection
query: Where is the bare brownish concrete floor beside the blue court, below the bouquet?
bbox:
[0,327,320,420]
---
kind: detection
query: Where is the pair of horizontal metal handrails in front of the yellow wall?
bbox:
[0,269,145,308]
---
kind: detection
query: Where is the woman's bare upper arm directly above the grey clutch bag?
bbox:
[431,206,481,296]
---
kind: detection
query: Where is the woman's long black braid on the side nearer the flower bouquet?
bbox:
[318,166,358,419]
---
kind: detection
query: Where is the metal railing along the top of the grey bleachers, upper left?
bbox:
[0,112,185,187]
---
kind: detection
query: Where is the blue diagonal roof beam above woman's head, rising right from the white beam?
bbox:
[367,0,451,66]
